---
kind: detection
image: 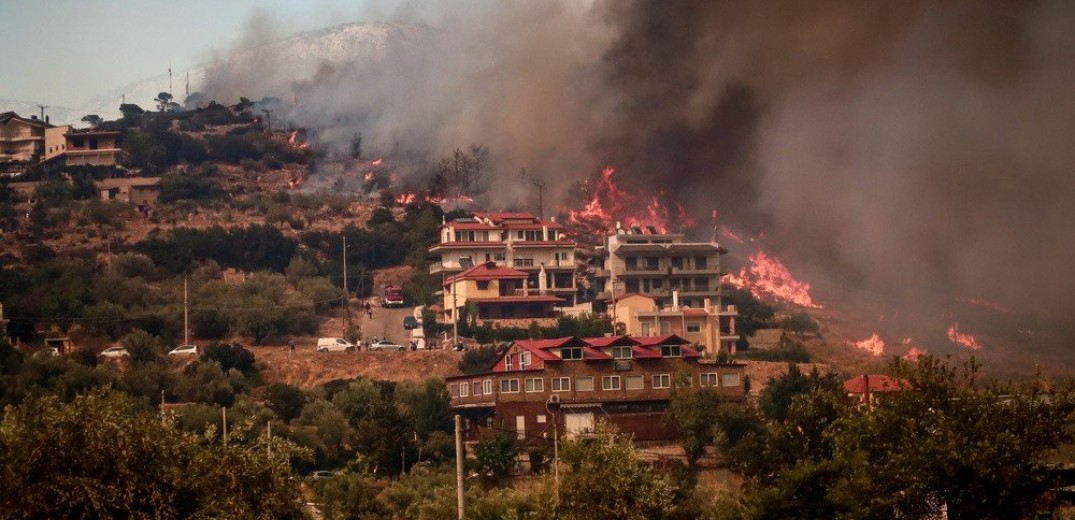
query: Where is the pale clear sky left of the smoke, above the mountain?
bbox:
[0,0,393,107]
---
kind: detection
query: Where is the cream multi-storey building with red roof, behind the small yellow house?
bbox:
[429,212,577,308]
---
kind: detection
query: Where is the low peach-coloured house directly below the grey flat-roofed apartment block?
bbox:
[608,291,739,353]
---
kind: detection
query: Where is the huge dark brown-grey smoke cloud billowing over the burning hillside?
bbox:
[199,0,1075,328]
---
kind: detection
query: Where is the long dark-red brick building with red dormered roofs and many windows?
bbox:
[446,334,746,444]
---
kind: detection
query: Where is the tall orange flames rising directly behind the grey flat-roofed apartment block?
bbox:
[568,168,696,233]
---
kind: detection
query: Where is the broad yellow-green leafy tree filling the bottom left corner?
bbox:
[0,392,303,518]
